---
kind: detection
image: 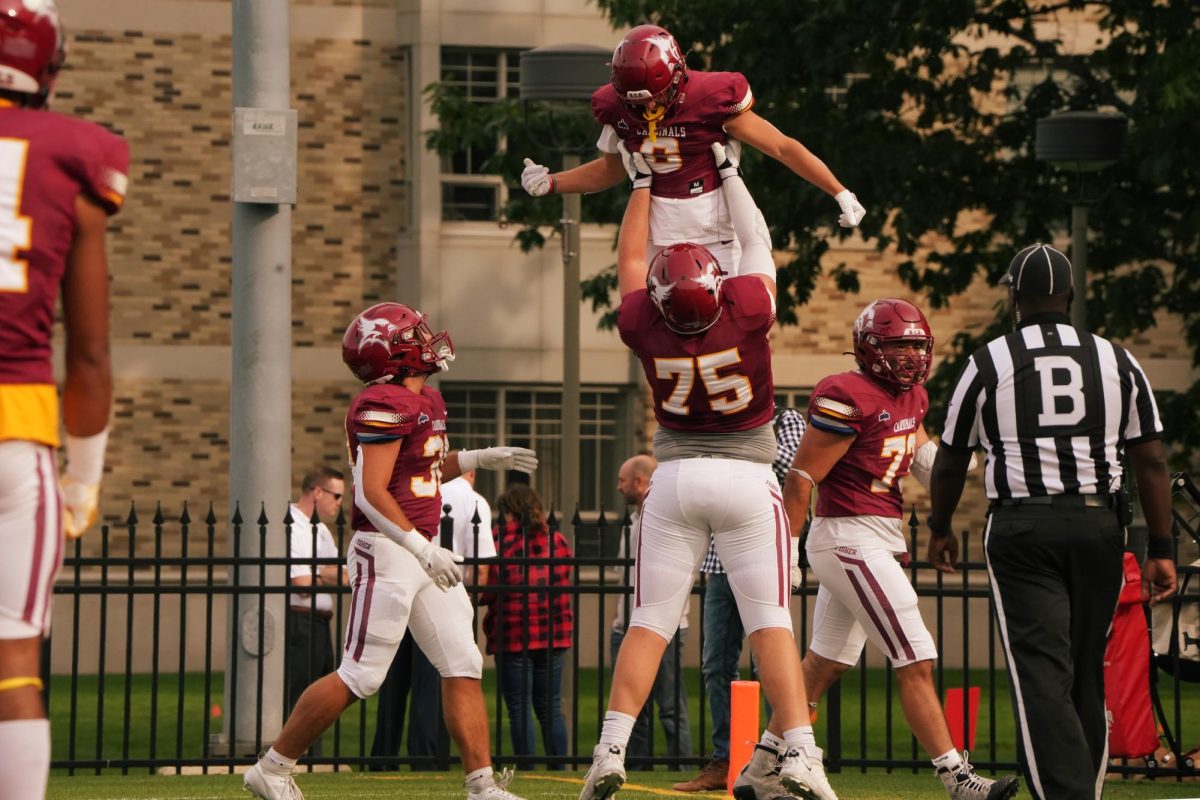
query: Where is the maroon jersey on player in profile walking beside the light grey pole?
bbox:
[346,384,450,539]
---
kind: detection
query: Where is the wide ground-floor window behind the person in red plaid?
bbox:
[440,381,636,518]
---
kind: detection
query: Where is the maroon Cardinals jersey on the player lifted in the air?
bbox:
[592,70,754,198]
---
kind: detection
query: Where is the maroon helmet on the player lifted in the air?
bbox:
[612,25,688,114]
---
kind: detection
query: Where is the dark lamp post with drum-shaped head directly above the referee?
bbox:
[1033,112,1128,330]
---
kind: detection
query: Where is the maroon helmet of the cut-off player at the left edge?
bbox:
[0,0,66,108]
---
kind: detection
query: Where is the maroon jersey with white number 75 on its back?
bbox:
[617,275,775,433]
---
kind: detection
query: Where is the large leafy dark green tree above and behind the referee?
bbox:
[433,0,1200,463]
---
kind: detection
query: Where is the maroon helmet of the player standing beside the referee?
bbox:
[854,297,934,391]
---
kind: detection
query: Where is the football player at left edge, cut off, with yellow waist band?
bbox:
[0,0,130,800]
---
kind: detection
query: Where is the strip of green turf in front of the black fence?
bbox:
[48,771,1200,800]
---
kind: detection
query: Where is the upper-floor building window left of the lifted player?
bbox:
[442,47,521,222]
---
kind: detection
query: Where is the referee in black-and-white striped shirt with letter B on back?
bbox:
[929,245,1175,800]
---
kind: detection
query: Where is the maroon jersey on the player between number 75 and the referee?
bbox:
[809,371,929,517]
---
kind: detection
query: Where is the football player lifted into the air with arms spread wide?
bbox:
[521,25,866,275]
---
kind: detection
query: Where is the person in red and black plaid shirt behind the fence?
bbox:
[479,485,575,769]
